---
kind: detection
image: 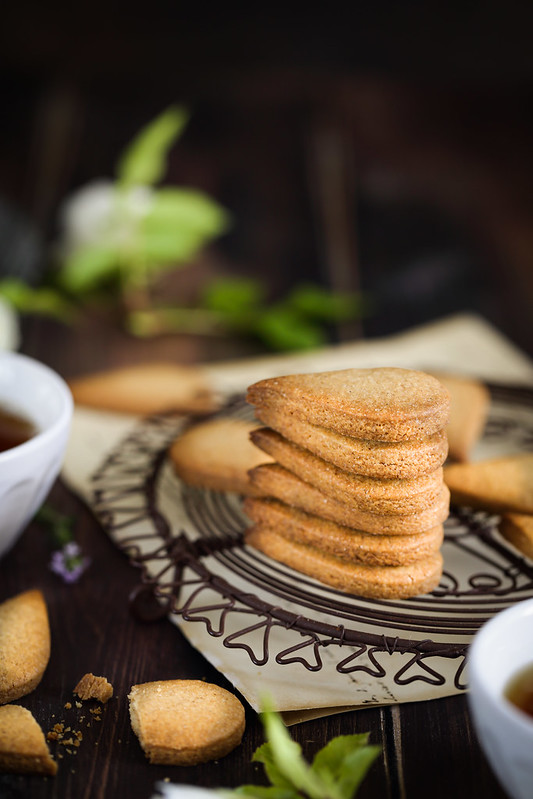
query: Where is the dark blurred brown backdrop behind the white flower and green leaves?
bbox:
[0,0,533,355]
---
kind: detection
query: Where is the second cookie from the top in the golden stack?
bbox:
[252,407,448,479]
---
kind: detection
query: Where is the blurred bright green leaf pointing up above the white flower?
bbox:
[116,106,189,188]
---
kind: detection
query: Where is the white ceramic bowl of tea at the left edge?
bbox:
[0,352,72,557]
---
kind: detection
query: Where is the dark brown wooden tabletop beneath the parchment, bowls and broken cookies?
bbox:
[0,320,505,799]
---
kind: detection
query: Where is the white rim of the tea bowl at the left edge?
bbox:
[0,350,74,466]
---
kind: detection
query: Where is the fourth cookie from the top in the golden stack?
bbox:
[250,463,450,536]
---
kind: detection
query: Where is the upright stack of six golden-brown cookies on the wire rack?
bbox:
[244,368,450,598]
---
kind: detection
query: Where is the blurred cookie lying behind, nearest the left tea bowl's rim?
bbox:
[69,362,217,415]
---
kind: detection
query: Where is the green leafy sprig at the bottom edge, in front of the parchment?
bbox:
[227,710,381,799]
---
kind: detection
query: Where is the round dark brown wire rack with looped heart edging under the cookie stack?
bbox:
[93,386,533,689]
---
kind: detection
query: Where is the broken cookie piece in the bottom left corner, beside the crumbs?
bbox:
[0,705,57,776]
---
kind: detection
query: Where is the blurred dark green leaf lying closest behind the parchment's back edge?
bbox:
[254,306,326,350]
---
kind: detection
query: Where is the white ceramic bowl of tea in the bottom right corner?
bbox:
[468,599,533,799]
